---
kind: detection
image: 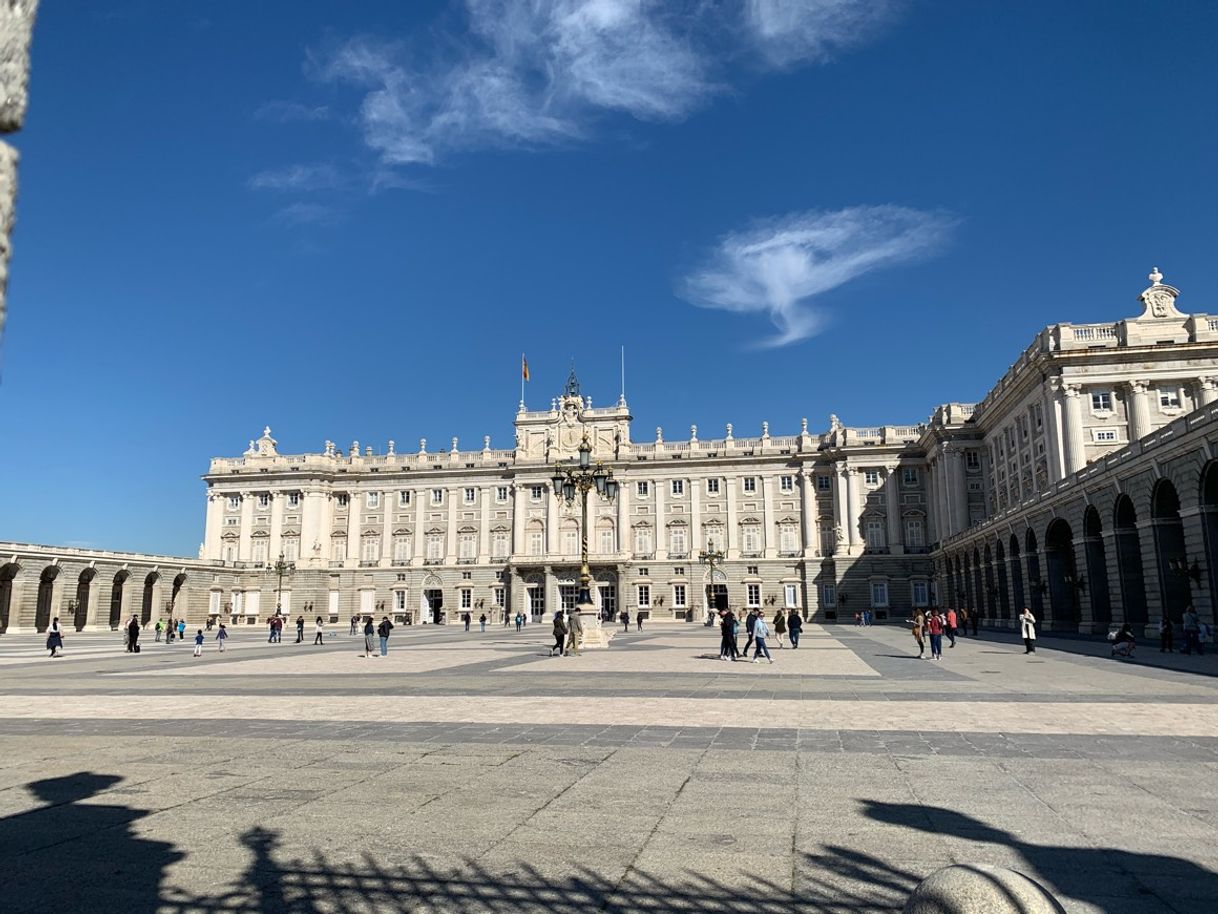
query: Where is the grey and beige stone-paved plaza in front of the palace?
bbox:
[0,624,1218,914]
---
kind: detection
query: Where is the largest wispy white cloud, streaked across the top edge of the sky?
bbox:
[314,0,896,166]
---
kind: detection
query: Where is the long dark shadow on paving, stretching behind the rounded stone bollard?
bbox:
[862,801,1218,912]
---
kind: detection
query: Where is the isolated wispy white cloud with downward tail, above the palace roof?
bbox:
[678,206,956,347]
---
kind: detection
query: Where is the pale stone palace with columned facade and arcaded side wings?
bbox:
[7,269,1218,631]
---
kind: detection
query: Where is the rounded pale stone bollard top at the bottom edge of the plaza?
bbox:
[904,864,1066,914]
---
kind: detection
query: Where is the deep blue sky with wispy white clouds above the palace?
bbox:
[0,0,1218,554]
